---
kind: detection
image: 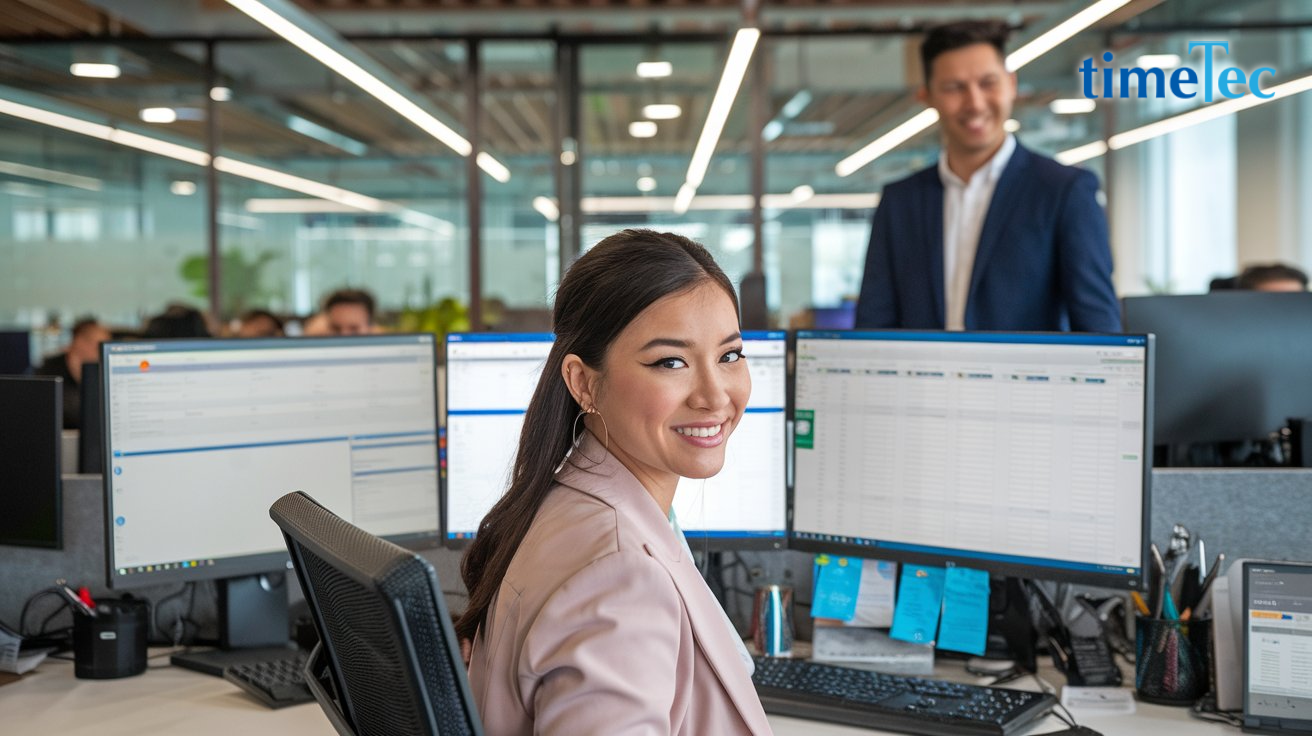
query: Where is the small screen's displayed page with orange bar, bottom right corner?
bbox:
[1244,563,1312,728]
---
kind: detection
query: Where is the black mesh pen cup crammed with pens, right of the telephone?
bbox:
[1135,617,1212,706]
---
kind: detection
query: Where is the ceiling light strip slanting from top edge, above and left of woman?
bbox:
[228,0,510,182]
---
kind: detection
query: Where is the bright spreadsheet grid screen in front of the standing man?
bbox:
[791,331,1152,588]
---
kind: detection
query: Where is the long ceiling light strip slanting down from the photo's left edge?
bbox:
[0,91,455,235]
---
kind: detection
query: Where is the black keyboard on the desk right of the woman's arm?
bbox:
[752,657,1056,736]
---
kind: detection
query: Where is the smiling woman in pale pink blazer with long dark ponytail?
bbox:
[457,230,770,736]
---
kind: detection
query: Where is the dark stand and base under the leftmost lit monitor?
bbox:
[169,572,294,677]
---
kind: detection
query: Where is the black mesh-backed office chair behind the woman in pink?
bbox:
[269,492,483,736]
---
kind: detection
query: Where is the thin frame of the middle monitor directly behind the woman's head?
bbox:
[442,329,792,552]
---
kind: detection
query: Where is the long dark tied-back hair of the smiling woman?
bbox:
[455,230,737,640]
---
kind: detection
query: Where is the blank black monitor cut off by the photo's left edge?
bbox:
[0,377,64,550]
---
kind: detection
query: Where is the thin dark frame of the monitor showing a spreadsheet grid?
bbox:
[789,329,1156,590]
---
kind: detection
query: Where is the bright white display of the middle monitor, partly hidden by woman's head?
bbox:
[446,332,786,539]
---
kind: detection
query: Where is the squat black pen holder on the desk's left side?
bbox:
[73,598,150,680]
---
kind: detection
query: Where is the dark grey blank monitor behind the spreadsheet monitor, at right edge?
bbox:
[1124,291,1312,445]
